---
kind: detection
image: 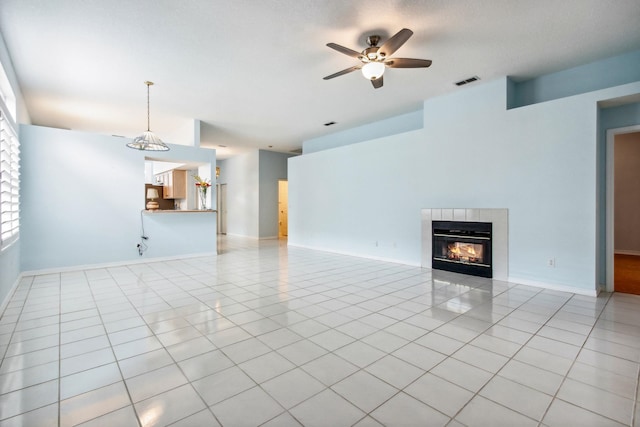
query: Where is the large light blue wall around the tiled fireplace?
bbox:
[289,78,640,290]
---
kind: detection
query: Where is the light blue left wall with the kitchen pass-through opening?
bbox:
[21,126,216,271]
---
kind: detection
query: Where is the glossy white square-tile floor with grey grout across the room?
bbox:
[0,238,640,427]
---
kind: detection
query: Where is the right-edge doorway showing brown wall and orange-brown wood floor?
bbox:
[607,126,640,295]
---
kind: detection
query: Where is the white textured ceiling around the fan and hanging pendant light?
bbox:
[0,0,640,158]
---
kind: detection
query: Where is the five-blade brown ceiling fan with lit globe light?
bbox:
[324,28,431,89]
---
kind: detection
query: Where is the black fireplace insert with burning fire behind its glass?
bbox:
[431,221,493,277]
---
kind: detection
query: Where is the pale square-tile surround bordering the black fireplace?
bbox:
[421,208,509,280]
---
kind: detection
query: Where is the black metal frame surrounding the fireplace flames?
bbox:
[431,221,493,278]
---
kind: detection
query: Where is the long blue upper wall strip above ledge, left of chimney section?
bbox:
[302,110,423,154]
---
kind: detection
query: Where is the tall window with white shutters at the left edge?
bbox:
[0,104,20,249]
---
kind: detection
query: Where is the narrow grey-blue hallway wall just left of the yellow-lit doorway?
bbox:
[259,150,291,238]
